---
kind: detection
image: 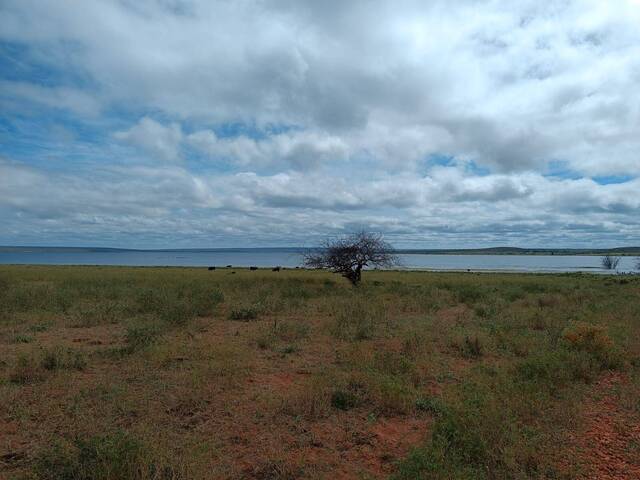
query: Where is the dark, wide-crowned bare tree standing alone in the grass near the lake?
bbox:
[304,231,398,285]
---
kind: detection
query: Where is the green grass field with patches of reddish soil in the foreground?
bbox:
[0,266,640,480]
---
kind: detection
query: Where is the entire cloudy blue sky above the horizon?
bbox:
[0,0,640,248]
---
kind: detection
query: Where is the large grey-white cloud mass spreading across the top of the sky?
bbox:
[0,0,640,175]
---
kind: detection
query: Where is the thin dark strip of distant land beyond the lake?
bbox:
[0,246,640,256]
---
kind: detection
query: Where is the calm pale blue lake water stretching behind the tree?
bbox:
[0,248,635,273]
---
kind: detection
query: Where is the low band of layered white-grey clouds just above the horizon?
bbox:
[0,158,640,246]
